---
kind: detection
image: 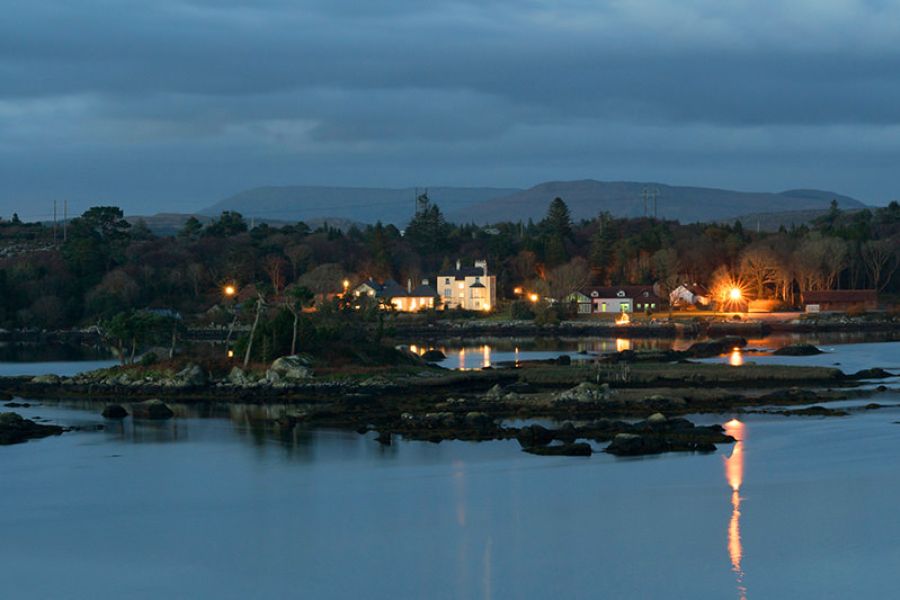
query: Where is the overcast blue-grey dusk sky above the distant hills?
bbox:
[0,0,900,219]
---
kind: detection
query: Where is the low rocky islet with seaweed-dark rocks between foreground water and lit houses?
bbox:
[0,337,891,456]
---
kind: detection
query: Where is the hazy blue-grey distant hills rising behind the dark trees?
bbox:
[200,179,865,227]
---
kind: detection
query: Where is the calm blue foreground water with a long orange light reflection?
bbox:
[0,343,900,600]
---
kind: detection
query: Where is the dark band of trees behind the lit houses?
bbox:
[0,198,900,329]
